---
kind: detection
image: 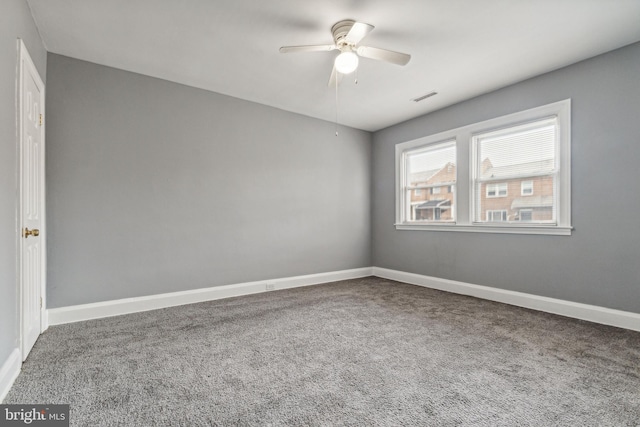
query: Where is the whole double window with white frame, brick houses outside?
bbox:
[395,100,571,235]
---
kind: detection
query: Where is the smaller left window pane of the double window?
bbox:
[405,141,456,222]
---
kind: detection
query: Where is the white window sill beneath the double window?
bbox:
[395,224,573,236]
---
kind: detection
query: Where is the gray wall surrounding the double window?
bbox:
[372,43,640,312]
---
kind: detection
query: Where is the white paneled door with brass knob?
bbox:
[19,41,46,360]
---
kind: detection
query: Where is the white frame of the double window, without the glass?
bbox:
[395,99,573,236]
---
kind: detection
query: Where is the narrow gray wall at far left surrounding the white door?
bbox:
[0,0,47,366]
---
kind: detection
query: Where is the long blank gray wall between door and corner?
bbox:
[47,54,371,308]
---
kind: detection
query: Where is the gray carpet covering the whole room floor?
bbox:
[5,277,640,427]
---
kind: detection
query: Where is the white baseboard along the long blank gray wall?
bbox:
[47,267,373,325]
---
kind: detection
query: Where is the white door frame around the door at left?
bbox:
[16,39,48,360]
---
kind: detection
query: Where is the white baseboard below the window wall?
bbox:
[373,267,640,331]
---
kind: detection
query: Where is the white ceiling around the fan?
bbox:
[28,0,640,131]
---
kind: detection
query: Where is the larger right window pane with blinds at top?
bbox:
[473,118,557,223]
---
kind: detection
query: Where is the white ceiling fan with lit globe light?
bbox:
[280,19,411,86]
